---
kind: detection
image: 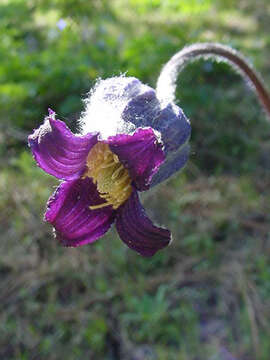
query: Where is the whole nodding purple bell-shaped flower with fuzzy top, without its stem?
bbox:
[29,76,190,256]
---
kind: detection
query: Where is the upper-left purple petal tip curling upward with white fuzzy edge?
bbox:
[28,114,97,180]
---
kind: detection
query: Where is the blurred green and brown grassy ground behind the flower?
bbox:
[0,0,270,360]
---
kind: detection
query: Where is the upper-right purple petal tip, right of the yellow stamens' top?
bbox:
[106,128,165,191]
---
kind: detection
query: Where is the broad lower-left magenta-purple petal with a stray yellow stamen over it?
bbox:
[45,178,115,247]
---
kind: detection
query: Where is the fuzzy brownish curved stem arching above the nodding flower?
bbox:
[156,43,270,118]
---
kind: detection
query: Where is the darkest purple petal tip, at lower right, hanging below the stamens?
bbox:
[116,191,171,256]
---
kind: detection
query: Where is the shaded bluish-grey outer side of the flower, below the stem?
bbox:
[122,96,191,187]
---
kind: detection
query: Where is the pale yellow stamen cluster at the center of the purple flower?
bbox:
[83,142,132,210]
